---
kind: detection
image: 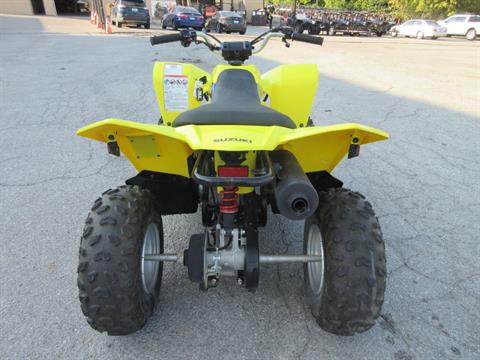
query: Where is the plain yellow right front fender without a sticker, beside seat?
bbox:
[261,64,318,127]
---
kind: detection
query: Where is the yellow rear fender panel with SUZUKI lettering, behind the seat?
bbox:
[77,119,388,177]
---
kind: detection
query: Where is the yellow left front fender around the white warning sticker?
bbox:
[153,62,210,126]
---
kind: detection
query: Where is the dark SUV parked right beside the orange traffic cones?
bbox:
[110,0,150,29]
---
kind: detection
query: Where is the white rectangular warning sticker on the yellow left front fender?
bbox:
[163,75,188,111]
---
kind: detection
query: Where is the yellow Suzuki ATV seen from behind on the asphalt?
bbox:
[78,27,388,335]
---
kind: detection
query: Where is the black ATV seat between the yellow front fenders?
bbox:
[172,69,296,129]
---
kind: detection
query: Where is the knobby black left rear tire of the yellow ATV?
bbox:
[78,186,163,335]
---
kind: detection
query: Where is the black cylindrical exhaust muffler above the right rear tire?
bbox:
[270,150,318,220]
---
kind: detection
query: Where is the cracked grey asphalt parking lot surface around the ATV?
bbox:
[0,16,480,360]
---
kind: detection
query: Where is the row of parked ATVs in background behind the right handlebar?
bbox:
[290,10,396,37]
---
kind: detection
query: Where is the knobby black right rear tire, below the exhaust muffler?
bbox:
[304,189,386,335]
